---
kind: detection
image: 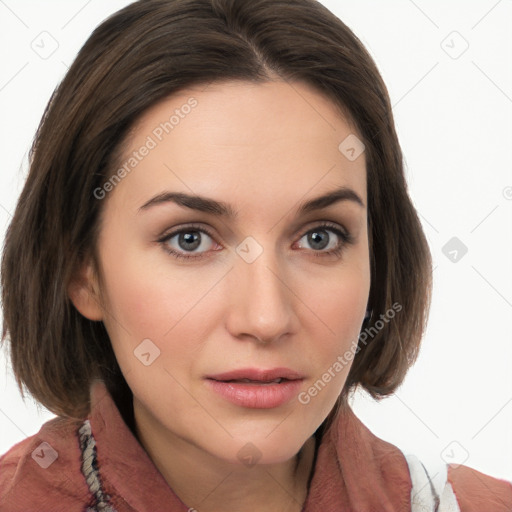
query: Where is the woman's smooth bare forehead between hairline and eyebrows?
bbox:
[106,81,366,214]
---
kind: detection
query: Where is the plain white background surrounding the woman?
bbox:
[0,0,512,481]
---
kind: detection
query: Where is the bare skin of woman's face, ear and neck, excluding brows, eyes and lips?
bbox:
[70,81,370,512]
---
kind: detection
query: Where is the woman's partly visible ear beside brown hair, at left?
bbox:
[68,262,104,321]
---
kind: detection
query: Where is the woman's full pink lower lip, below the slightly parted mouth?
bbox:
[207,379,302,409]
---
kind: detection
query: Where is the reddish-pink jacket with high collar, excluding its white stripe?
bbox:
[0,381,512,512]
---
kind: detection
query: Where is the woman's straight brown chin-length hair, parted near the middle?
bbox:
[1,0,432,434]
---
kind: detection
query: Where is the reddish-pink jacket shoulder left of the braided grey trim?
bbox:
[0,417,91,512]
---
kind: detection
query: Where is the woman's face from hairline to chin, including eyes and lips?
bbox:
[78,82,370,463]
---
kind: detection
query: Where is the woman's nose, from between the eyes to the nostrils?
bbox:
[226,243,297,343]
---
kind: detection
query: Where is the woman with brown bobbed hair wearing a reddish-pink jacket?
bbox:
[0,0,512,512]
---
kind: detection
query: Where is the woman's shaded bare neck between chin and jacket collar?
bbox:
[135,410,315,512]
